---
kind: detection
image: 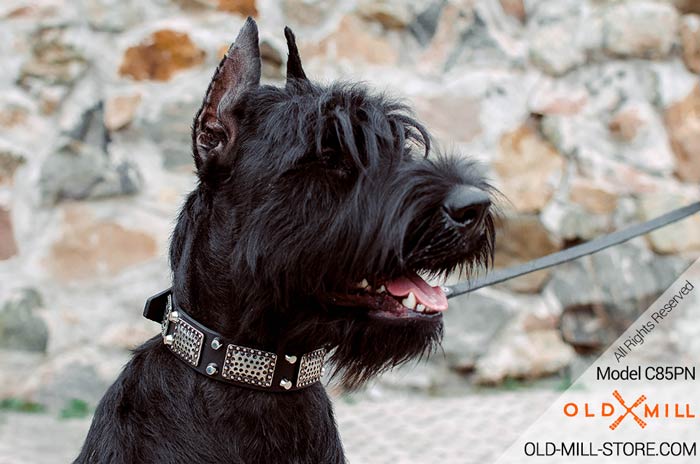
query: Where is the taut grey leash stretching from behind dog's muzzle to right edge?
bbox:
[443,201,700,298]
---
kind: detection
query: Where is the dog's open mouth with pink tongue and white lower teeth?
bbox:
[330,271,447,318]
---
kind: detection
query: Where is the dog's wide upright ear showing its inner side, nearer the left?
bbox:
[192,17,260,169]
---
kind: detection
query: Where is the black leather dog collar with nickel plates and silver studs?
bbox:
[143,289,327,392]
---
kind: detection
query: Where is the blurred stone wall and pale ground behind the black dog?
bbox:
[0,0,700,464]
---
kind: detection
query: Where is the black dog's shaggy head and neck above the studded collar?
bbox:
[171,19,494,386]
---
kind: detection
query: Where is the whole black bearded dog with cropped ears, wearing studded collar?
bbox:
[76,19,494,464]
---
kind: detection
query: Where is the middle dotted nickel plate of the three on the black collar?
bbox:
[221,345,277,387]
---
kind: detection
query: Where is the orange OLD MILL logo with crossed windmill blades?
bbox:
[564,390,695,430]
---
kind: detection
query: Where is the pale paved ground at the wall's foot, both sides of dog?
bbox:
[0,391,558,464]
